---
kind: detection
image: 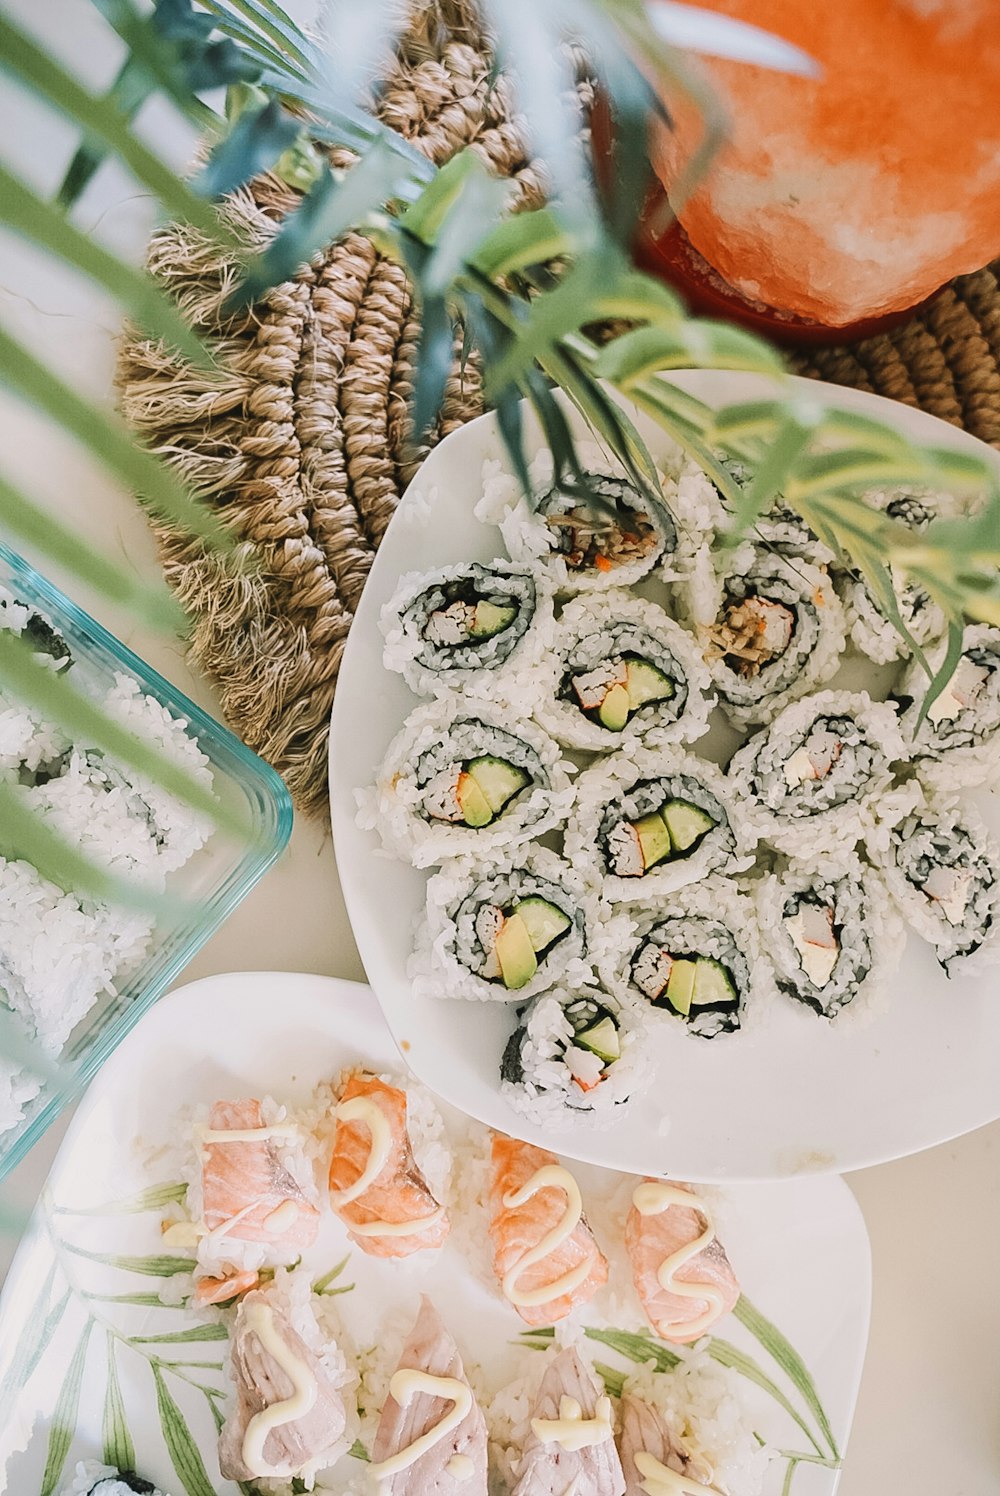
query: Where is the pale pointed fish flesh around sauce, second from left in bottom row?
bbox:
[371,1297,487,1496]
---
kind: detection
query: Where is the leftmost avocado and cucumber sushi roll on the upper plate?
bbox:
[359,694,573,868]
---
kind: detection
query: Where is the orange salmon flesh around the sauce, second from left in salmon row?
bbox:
[329,1071,451,1257]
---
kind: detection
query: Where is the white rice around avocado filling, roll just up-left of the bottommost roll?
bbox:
[407,845,605,1002]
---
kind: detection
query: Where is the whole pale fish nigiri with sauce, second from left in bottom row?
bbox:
[368,1297,487,1496]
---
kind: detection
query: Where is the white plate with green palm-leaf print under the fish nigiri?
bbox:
[0,972,871,1496]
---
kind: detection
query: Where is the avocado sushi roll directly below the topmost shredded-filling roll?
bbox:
[537,591,711,752]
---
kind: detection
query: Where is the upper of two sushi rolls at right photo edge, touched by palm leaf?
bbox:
[898,624,1000,791]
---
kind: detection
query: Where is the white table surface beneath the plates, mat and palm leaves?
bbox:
[0,0,1000,1496]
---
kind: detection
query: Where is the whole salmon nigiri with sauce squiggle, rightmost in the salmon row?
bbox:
[626,1179,740,1345]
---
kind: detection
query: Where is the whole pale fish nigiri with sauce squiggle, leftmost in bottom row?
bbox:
[219,1276,350,1486]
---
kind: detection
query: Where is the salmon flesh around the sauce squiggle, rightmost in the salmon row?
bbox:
[626,1179,740,1345]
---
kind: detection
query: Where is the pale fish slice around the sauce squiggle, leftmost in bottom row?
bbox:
[219,1284,347,1481]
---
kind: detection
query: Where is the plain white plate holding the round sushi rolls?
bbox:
[329,373,1000,1180]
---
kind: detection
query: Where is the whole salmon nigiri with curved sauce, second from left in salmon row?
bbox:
[329,1071,449,1257]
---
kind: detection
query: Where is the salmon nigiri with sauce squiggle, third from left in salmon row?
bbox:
[490,1132,608,1325]
